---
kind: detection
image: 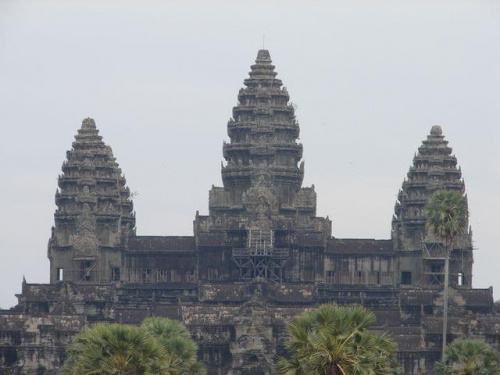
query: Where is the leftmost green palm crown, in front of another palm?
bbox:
[63,324,168,375]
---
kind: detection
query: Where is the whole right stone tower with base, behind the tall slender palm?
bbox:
[392,125,473,287]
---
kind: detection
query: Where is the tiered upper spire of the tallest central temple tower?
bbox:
[222,50,304,203]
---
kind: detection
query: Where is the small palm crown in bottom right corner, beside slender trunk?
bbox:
[436,340,500,375]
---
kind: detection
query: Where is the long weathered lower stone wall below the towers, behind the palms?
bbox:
[0,279,500,375]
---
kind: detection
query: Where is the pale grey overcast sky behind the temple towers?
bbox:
[0,0,500,308]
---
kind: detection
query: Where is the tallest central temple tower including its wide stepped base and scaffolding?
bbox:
[194,50,331,282]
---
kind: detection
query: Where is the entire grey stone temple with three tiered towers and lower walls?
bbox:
[0,50,500,375]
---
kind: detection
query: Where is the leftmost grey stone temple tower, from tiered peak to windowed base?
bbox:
[48,118,135,283]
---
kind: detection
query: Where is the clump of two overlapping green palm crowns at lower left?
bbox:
[64,318,205,375]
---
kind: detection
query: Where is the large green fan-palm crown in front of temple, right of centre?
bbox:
[278,304,399,375]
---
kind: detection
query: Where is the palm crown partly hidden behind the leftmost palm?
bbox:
[141,317,206,375]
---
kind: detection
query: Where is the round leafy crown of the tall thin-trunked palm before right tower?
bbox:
[425,190,469,246]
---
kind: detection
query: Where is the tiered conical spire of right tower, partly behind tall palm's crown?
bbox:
[392,125,465,250]
